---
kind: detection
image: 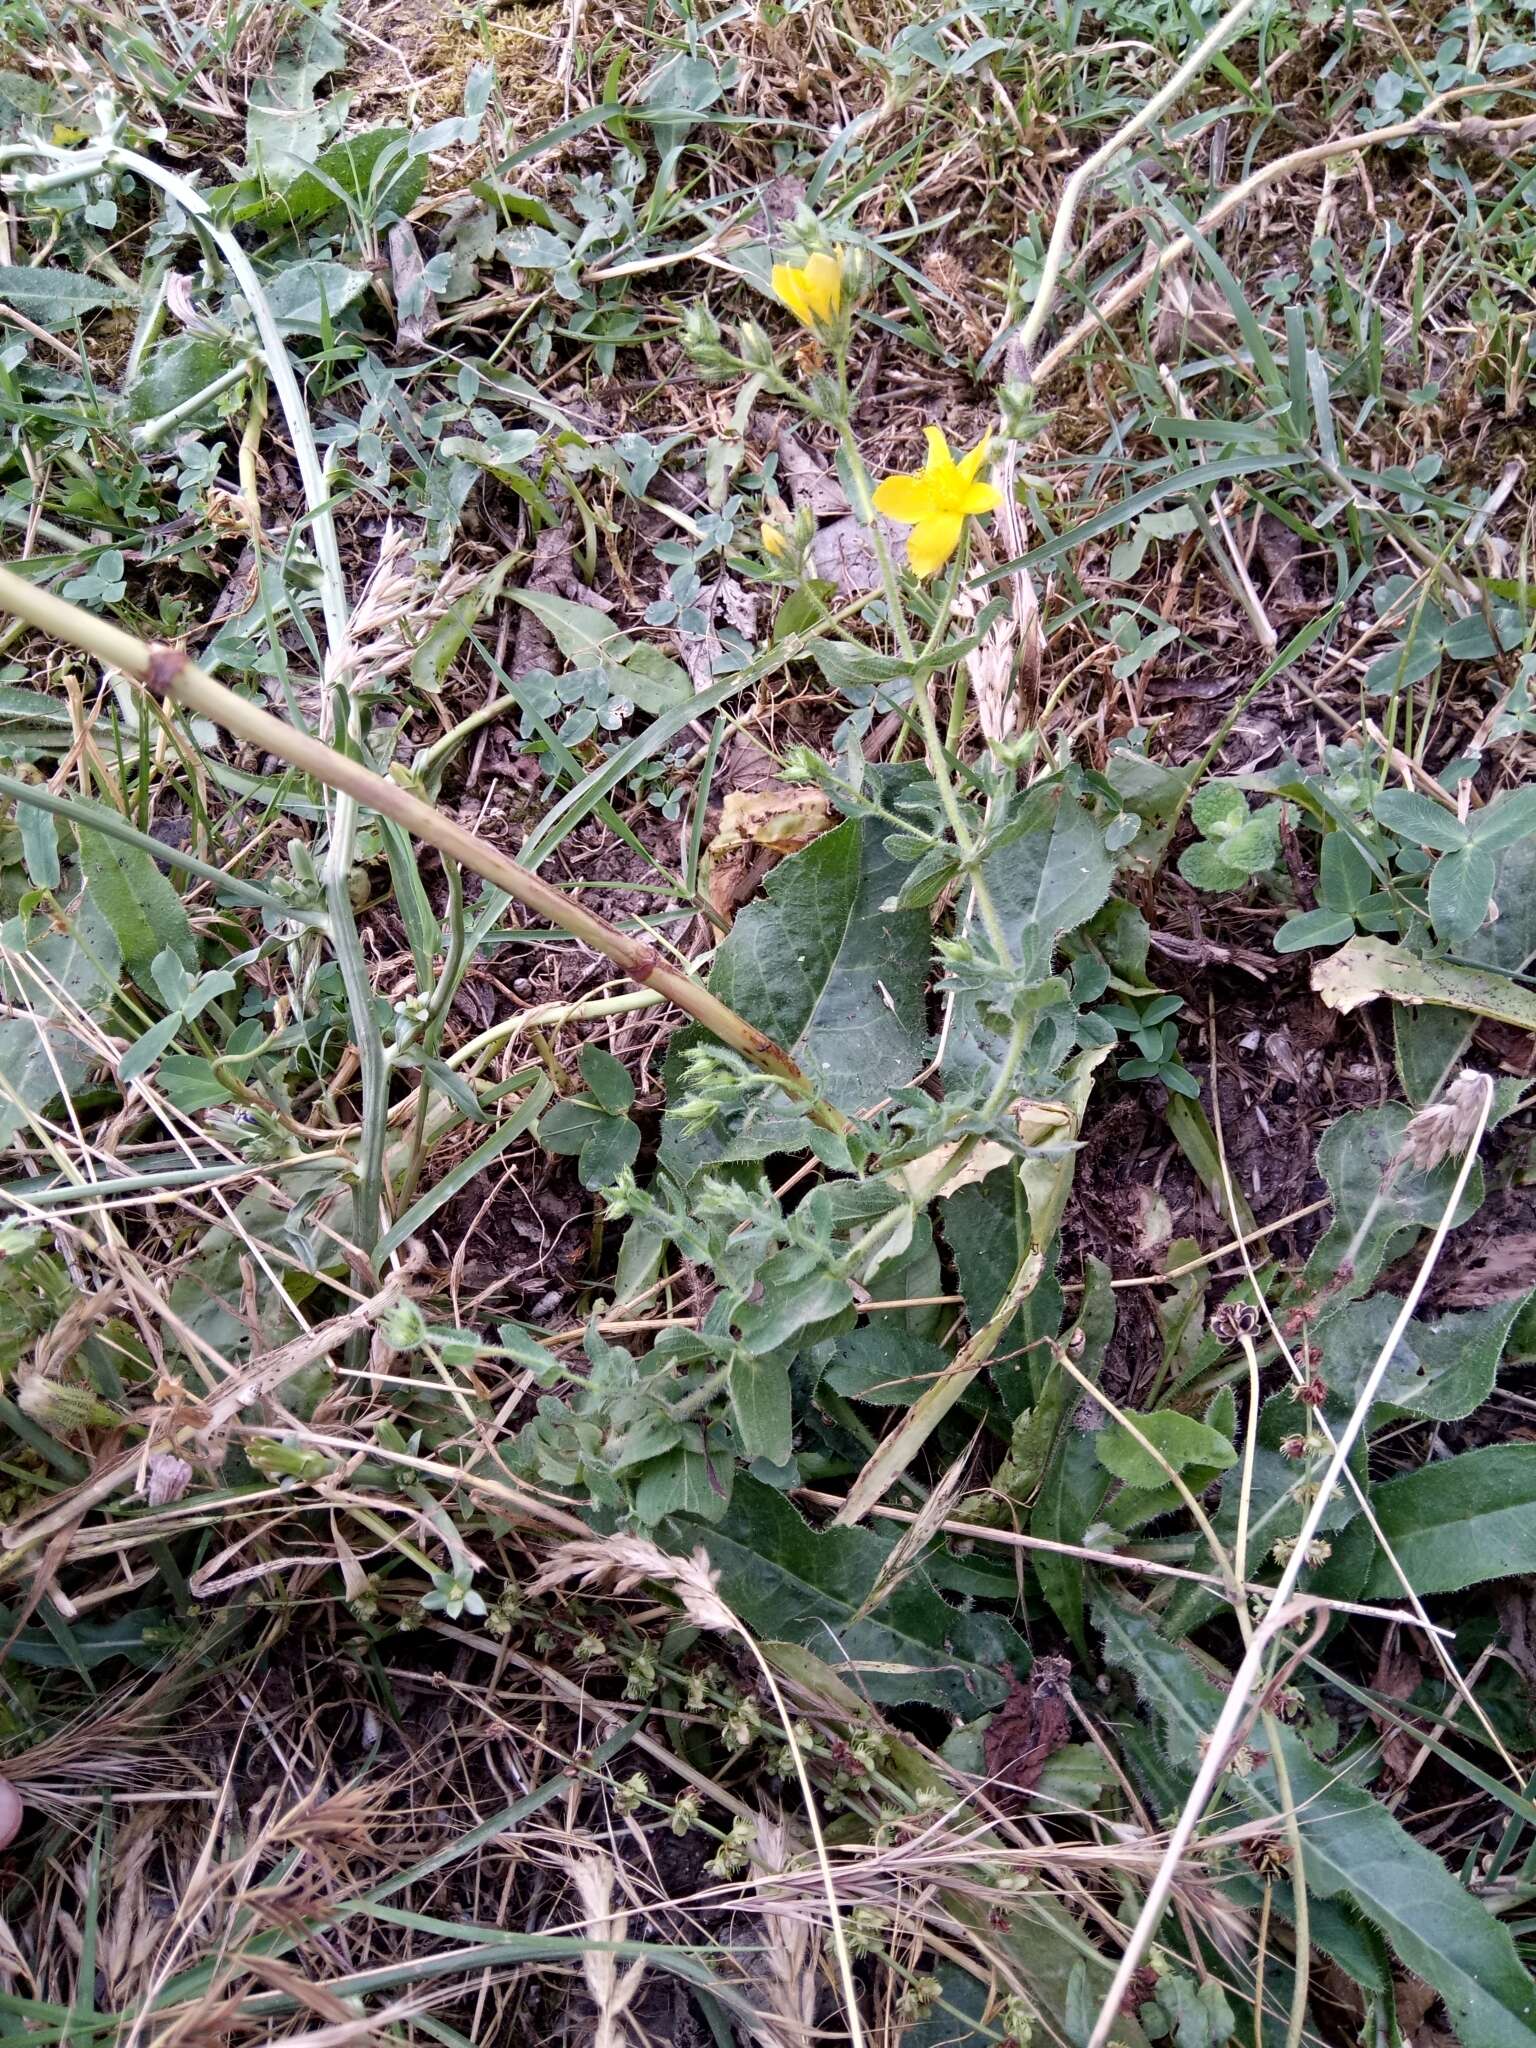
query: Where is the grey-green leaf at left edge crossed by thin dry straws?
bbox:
[0,899,123,1143]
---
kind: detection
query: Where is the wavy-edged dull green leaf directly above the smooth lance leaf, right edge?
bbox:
[1313,1294,1530,1423]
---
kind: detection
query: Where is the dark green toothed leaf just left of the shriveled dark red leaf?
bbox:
[676,1477,1030,1720]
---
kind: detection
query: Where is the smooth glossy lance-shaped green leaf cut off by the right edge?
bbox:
[1362,1444,1536,1599]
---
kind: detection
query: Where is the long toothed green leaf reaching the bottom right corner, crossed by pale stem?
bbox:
[1094,1597,1536,2048]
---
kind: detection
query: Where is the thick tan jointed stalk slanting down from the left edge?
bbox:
[0,567,846,1130]
